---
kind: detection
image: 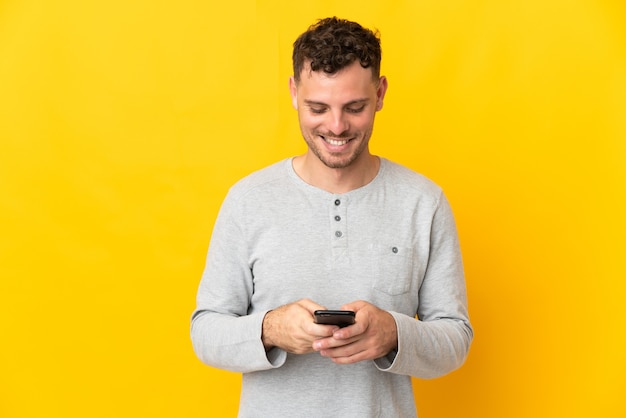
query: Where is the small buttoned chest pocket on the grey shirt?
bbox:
[366,244,415,295]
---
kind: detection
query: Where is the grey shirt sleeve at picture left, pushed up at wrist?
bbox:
[191,189,287,373]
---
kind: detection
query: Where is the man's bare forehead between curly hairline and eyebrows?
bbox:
[297,62,376,103]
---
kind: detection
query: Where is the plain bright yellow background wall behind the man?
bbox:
[0,0,626,418]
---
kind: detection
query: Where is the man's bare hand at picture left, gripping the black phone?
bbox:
[261,299,339,354]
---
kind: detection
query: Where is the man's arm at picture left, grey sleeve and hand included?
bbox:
[191,191,336,372]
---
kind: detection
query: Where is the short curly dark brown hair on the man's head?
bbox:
[292,17,382,82]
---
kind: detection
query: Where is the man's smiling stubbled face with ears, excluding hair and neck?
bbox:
[289,62,387,168]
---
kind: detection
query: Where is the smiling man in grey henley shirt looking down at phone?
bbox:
[191,18,473,418]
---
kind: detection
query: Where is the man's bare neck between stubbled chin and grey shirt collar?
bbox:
[292,152,380,194]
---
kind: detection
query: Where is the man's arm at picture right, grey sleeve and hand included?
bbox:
[314,195,473,378]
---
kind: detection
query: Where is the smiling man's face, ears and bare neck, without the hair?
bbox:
[289,60,387,193]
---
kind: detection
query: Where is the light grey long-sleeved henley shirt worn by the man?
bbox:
[191,159,473,418]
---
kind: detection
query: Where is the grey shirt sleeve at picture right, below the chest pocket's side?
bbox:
[375,194,474,378]
